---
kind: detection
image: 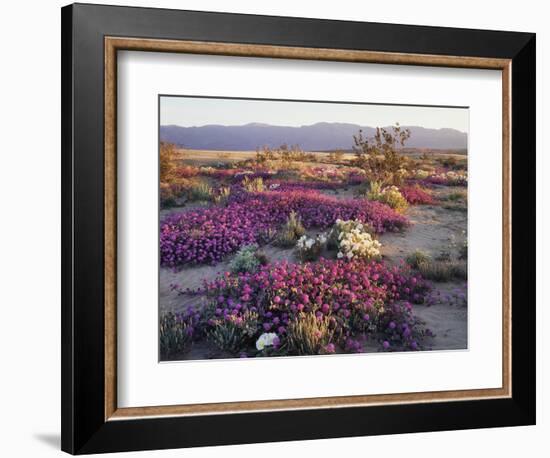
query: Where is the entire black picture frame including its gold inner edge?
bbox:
[62,4,536,454]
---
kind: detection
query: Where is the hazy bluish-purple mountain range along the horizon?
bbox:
[160,122,468,151]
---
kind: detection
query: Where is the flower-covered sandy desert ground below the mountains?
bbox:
[160,143,467,360]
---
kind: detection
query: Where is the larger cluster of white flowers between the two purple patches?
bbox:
[336,220,382,259]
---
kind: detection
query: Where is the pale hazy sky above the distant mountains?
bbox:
[160,96,469,133]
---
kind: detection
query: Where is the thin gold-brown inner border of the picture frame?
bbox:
[104,37,512,421]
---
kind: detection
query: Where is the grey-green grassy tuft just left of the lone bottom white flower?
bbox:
[206,311,259,353]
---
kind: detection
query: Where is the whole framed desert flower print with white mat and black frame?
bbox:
[62,4,535,454]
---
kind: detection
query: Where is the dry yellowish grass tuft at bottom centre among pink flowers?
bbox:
[286,312,334,355]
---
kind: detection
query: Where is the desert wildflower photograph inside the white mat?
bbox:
[158,95,469,361]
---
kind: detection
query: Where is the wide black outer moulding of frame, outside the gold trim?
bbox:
[61,4,536,454]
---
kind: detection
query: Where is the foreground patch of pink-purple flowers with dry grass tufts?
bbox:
[161,259,431,356]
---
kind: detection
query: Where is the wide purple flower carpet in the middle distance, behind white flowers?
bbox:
[160,190,408,267]
